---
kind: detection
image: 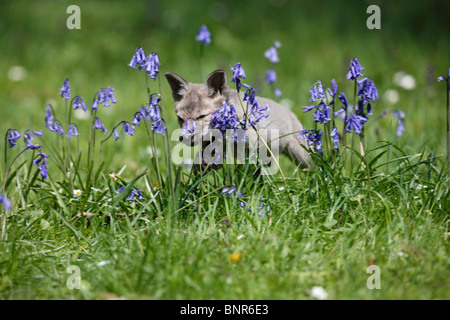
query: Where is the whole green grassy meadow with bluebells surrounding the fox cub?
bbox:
[0,0,450,300]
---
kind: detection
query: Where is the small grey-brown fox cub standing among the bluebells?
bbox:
[165,70,311,167]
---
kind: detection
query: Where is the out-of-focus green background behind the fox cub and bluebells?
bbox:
[0,0,450,167]
